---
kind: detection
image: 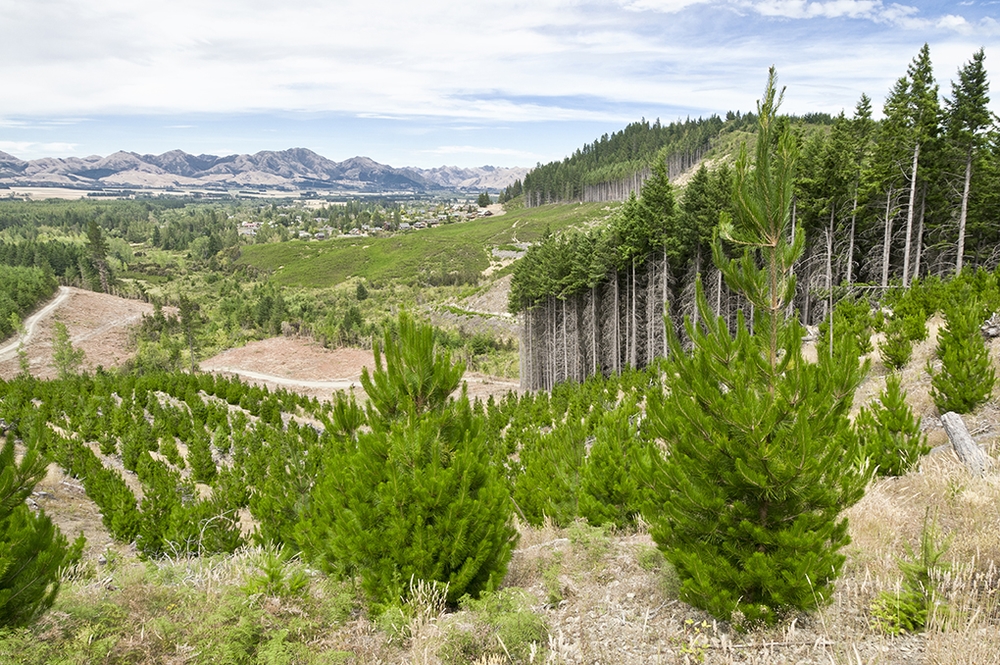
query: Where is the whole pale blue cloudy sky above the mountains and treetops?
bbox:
[0,0,1000,168]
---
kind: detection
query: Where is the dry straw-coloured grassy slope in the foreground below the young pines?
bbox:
[0,300,1000,665]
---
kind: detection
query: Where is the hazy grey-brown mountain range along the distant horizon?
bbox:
[0,148,530,192]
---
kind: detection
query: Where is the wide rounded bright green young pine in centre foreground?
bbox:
[295,315,517,606]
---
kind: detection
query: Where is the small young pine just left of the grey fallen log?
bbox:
[854,373,931,476]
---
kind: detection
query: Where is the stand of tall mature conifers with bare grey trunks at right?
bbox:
[510,45,1000,388]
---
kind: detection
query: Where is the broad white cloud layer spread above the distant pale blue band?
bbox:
[0,0,998,141]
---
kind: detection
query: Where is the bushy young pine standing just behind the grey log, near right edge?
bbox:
[928,299,996,413]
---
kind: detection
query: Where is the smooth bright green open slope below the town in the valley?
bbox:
[239,203,617,288]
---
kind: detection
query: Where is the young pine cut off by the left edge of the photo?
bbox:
[0,436,84,626]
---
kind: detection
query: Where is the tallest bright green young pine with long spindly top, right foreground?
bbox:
[643,69,867,628]
